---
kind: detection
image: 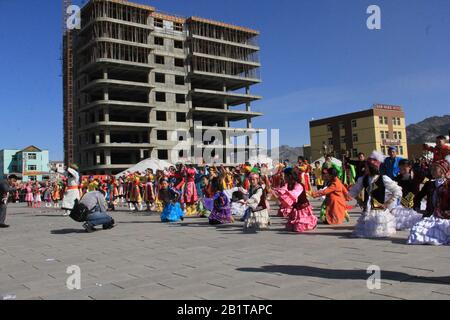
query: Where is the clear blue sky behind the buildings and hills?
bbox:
[0,0,450,159]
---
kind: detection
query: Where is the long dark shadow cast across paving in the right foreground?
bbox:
[236,265,450,285]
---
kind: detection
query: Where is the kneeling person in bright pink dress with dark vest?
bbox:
[273,168,317,233]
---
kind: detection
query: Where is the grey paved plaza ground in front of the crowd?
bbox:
[0,202,450,300]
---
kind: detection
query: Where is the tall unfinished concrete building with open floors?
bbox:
[64,0,261,174]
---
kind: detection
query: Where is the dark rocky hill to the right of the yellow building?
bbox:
[406,115,450,144]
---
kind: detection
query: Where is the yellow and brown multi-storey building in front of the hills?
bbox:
[310,104,408,159]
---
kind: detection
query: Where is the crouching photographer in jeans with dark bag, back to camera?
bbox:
[70,191,114,232]
